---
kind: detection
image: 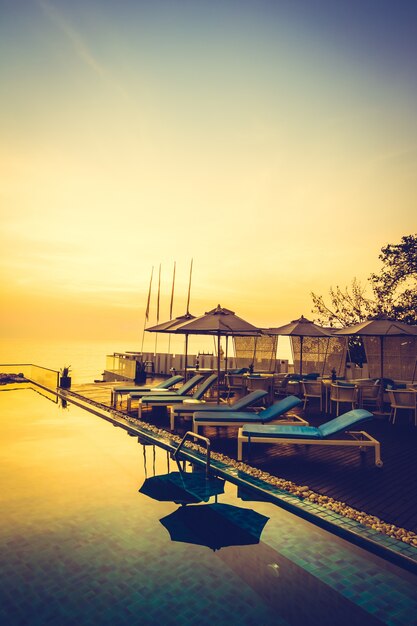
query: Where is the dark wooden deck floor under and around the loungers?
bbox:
[72,383,417,532]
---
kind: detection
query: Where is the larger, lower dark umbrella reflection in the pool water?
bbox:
[160,504,269,550]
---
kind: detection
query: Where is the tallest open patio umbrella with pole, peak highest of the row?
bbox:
[174,304,260,402]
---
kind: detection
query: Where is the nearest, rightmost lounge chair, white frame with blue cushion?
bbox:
[237,409,382,467]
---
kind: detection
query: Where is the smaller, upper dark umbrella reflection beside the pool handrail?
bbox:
[139,472,224,504]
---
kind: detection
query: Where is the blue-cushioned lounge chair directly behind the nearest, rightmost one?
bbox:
[193,396,308,433]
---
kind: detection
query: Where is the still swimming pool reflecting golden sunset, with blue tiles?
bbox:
[0,388,417,626]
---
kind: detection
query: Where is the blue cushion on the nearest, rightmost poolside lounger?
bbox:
[242,409,373,439]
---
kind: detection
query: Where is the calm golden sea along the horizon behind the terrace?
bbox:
[0,336,292,385]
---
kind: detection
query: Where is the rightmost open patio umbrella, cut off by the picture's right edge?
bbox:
[334,317,417,386]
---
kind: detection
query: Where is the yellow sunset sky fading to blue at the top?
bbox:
[0,0,417,349]
